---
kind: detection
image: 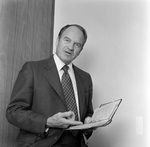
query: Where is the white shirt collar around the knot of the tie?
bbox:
[54,53,73,71]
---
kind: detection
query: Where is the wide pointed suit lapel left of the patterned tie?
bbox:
[44,56,65,103]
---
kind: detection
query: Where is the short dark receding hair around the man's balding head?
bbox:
[58,24,87,46]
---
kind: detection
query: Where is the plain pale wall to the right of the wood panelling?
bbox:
[54,0,150,147]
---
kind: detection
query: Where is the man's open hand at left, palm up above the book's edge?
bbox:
[47,111,82,128]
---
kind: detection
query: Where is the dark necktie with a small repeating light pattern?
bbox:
[62,65,79,136]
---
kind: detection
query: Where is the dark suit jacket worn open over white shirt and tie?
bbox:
[6,56,93,147]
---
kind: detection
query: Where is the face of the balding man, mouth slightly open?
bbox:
[56,26,84,64]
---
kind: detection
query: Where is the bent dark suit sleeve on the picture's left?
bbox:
[6,63,47,134]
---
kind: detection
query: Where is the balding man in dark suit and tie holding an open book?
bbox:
[6,24,93,147]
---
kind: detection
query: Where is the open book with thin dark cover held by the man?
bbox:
[67,99,122,130]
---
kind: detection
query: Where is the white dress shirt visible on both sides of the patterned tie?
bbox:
[54,54,80,120]
